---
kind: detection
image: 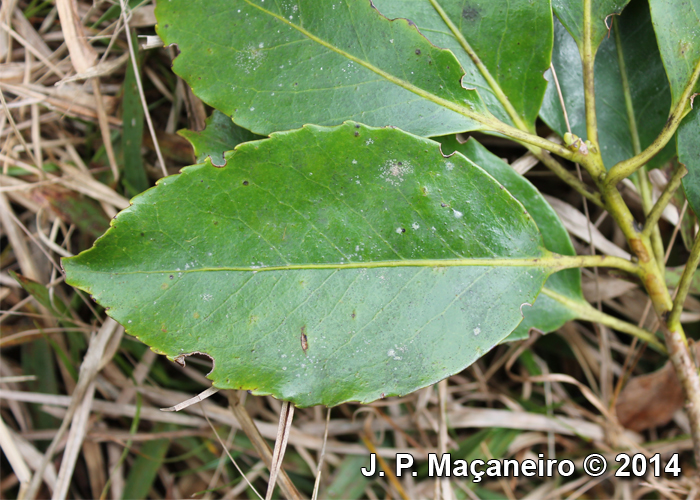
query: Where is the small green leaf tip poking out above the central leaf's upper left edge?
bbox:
[178,109,262,167]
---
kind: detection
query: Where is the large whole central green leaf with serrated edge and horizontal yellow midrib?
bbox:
[63,123,556,406]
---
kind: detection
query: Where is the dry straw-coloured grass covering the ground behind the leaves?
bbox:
[0,0,700,499]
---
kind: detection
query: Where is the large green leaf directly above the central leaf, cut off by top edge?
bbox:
[156,0,488,136]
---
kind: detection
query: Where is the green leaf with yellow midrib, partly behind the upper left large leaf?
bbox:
[373,0,552,130]
